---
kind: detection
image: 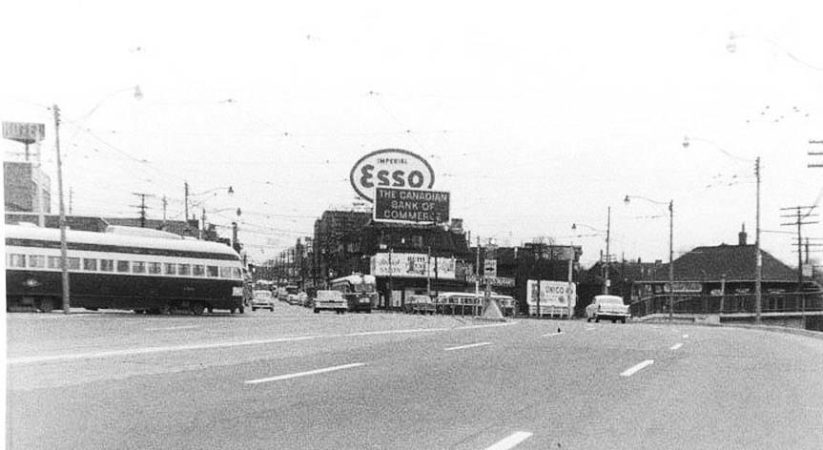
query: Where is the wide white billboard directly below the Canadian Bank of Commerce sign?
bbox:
[371,252,455,280]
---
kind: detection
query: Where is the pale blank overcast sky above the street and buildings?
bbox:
[0,0,823,265]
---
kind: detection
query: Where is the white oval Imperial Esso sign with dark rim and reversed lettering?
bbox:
[349,148,434,202]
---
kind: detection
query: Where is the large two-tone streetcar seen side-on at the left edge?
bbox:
[5,225,245,315]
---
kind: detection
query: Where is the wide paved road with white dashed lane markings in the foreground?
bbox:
[6,303,823,449]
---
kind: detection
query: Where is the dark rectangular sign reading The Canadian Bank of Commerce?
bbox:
[374,187,451,223]
